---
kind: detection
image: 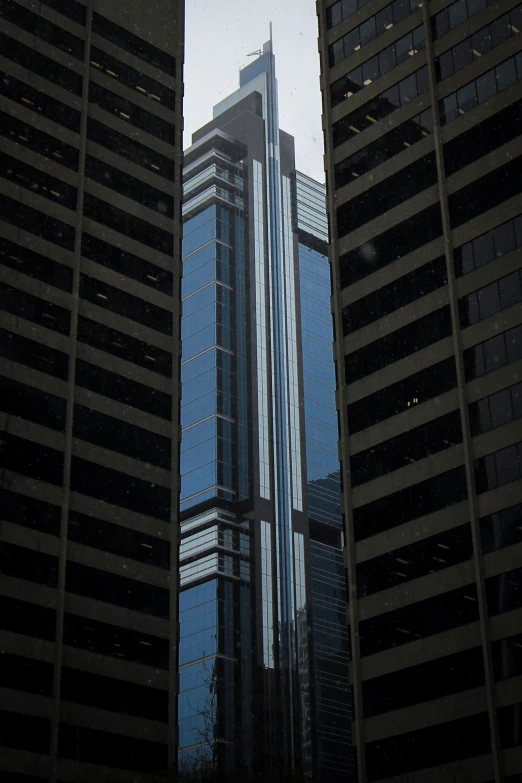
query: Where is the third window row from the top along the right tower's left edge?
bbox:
[330,25,425,108]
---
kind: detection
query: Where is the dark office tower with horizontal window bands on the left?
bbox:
[0,0,183,783]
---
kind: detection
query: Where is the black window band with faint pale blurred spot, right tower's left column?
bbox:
[339,203,442,288]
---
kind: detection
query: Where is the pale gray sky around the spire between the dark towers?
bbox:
[184,0,324,182]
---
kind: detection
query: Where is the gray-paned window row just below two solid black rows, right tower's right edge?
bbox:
[454,215,522,277]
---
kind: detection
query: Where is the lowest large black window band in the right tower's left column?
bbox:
[366,712,491,781]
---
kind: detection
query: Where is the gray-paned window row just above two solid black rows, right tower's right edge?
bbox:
[439,52,522,125]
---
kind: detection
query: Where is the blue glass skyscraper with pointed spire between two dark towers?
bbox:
[179,41,352,783]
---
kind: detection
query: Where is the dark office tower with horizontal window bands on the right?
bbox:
[318,0,522,783]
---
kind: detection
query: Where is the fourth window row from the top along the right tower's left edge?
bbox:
[332,65,429,147]
